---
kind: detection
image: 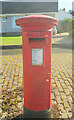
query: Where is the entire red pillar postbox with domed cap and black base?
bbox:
[16,15,57,118]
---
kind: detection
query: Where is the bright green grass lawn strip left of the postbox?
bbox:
[0,36,22,45]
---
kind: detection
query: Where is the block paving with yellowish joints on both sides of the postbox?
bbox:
[0,48,74,120]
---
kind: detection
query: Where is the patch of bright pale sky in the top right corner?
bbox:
[58,0,74,11]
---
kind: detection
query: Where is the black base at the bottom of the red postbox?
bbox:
[23,107,51,118]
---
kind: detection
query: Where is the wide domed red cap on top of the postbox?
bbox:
[15,15,58,31]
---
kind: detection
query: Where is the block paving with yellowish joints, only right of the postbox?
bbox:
[52,53,73,118]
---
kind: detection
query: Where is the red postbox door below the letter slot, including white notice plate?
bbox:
[25,36,51,111]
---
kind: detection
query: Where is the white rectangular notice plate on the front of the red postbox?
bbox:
[32,48,43,66]
